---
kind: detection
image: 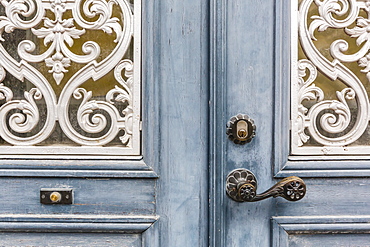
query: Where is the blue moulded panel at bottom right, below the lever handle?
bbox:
[272,215,370,247]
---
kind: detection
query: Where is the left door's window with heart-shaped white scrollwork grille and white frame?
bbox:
[0,0,141,155]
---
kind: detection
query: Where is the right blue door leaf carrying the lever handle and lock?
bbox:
[210,0,370,246]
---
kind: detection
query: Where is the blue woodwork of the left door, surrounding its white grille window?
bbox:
[0,0,210,246]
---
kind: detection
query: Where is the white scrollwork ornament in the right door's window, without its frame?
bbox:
[292,0,370,154]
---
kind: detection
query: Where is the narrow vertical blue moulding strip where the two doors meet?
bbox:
[209,0,227,246]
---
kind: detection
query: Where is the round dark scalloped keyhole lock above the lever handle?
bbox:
[226,114,256,144]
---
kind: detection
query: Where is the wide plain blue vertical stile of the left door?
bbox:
[143,0,209,247]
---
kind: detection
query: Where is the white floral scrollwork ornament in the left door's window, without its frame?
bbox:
[0,0,135,147]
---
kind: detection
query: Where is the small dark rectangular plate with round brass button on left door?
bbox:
[40,188,73,204]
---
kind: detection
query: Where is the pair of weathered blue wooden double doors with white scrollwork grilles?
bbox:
[0,0,370,247]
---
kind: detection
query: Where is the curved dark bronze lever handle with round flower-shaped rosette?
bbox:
[226,168,306,202]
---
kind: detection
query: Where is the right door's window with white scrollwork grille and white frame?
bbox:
[291,0,370,156]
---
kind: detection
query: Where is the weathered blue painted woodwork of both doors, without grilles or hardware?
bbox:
[0,0,370,247]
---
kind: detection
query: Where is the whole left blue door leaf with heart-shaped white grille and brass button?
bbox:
[0,0,210,247]
